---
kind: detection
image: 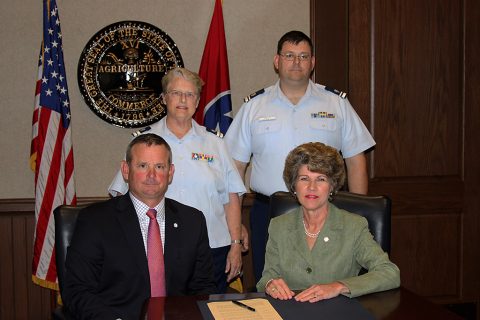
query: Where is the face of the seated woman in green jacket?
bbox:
[295,165,332,211]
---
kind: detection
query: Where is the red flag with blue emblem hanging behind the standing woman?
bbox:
[195,0,232,134]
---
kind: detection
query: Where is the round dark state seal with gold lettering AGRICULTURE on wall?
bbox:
[78,21,183,128]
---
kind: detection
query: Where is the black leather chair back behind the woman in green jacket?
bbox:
[270,191,392,253]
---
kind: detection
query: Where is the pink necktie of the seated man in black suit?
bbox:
[147,209,167,297]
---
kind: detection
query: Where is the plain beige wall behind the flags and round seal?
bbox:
[0,0,310,199]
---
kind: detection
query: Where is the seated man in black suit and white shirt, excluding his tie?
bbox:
[62,134,216,320]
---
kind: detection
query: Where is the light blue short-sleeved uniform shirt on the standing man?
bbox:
[224,81,375,196]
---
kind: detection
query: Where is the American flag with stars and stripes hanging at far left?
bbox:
[30,0,77,290]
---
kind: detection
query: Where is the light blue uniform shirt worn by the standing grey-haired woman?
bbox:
[108,117,246,248]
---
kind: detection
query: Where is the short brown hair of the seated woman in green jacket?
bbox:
[283,142,345,194]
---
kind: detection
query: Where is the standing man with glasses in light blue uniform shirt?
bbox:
[225,31,375,281]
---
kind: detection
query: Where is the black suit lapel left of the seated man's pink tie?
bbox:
[115,193,150,282]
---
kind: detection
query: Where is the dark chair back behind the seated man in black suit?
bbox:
[53,205,87,295]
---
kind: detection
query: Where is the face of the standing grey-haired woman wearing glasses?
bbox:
[164,77,200,121]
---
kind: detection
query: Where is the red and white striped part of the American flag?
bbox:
[32,58,76,289]
